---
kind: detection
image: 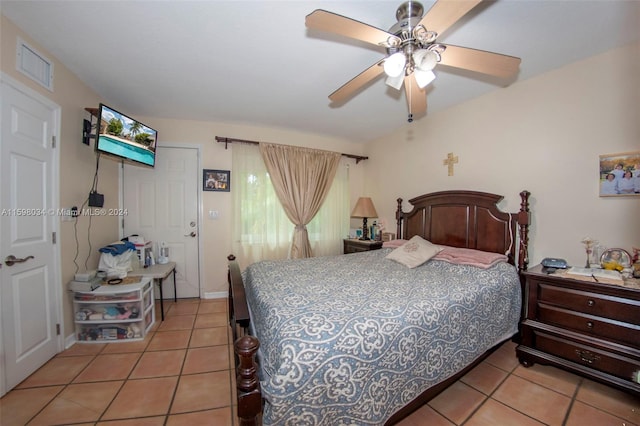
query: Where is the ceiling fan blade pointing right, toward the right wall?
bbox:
[440,44,521,78]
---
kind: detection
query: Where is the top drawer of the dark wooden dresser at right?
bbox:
[538,283,640,325]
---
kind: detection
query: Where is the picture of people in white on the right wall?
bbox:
[599,151,640,197]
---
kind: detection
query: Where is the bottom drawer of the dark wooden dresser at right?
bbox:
[535,331,640,384]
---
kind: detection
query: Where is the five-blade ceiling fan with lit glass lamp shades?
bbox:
[305,0,520,122]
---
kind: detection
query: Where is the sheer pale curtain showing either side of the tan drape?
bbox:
[231,143,349,267]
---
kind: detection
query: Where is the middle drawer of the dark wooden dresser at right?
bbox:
[538,303,640,346]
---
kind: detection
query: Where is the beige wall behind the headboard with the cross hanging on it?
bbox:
[365,43,640,266]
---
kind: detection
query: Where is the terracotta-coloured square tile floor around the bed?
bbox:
[0,299,640,426]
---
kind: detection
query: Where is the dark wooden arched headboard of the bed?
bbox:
[396,191,530,271]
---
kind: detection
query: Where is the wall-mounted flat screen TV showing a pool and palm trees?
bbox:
[96,104,158,167]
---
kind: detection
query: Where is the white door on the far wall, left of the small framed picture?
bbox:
[123,147,200,298]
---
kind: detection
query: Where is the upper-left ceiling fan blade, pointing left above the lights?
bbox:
[305,9,400,45]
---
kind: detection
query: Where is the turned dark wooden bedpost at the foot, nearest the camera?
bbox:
[234,335,262,426]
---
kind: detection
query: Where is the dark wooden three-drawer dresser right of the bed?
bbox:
[516,265,640,395]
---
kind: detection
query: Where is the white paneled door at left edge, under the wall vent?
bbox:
[0,76,62,395]
